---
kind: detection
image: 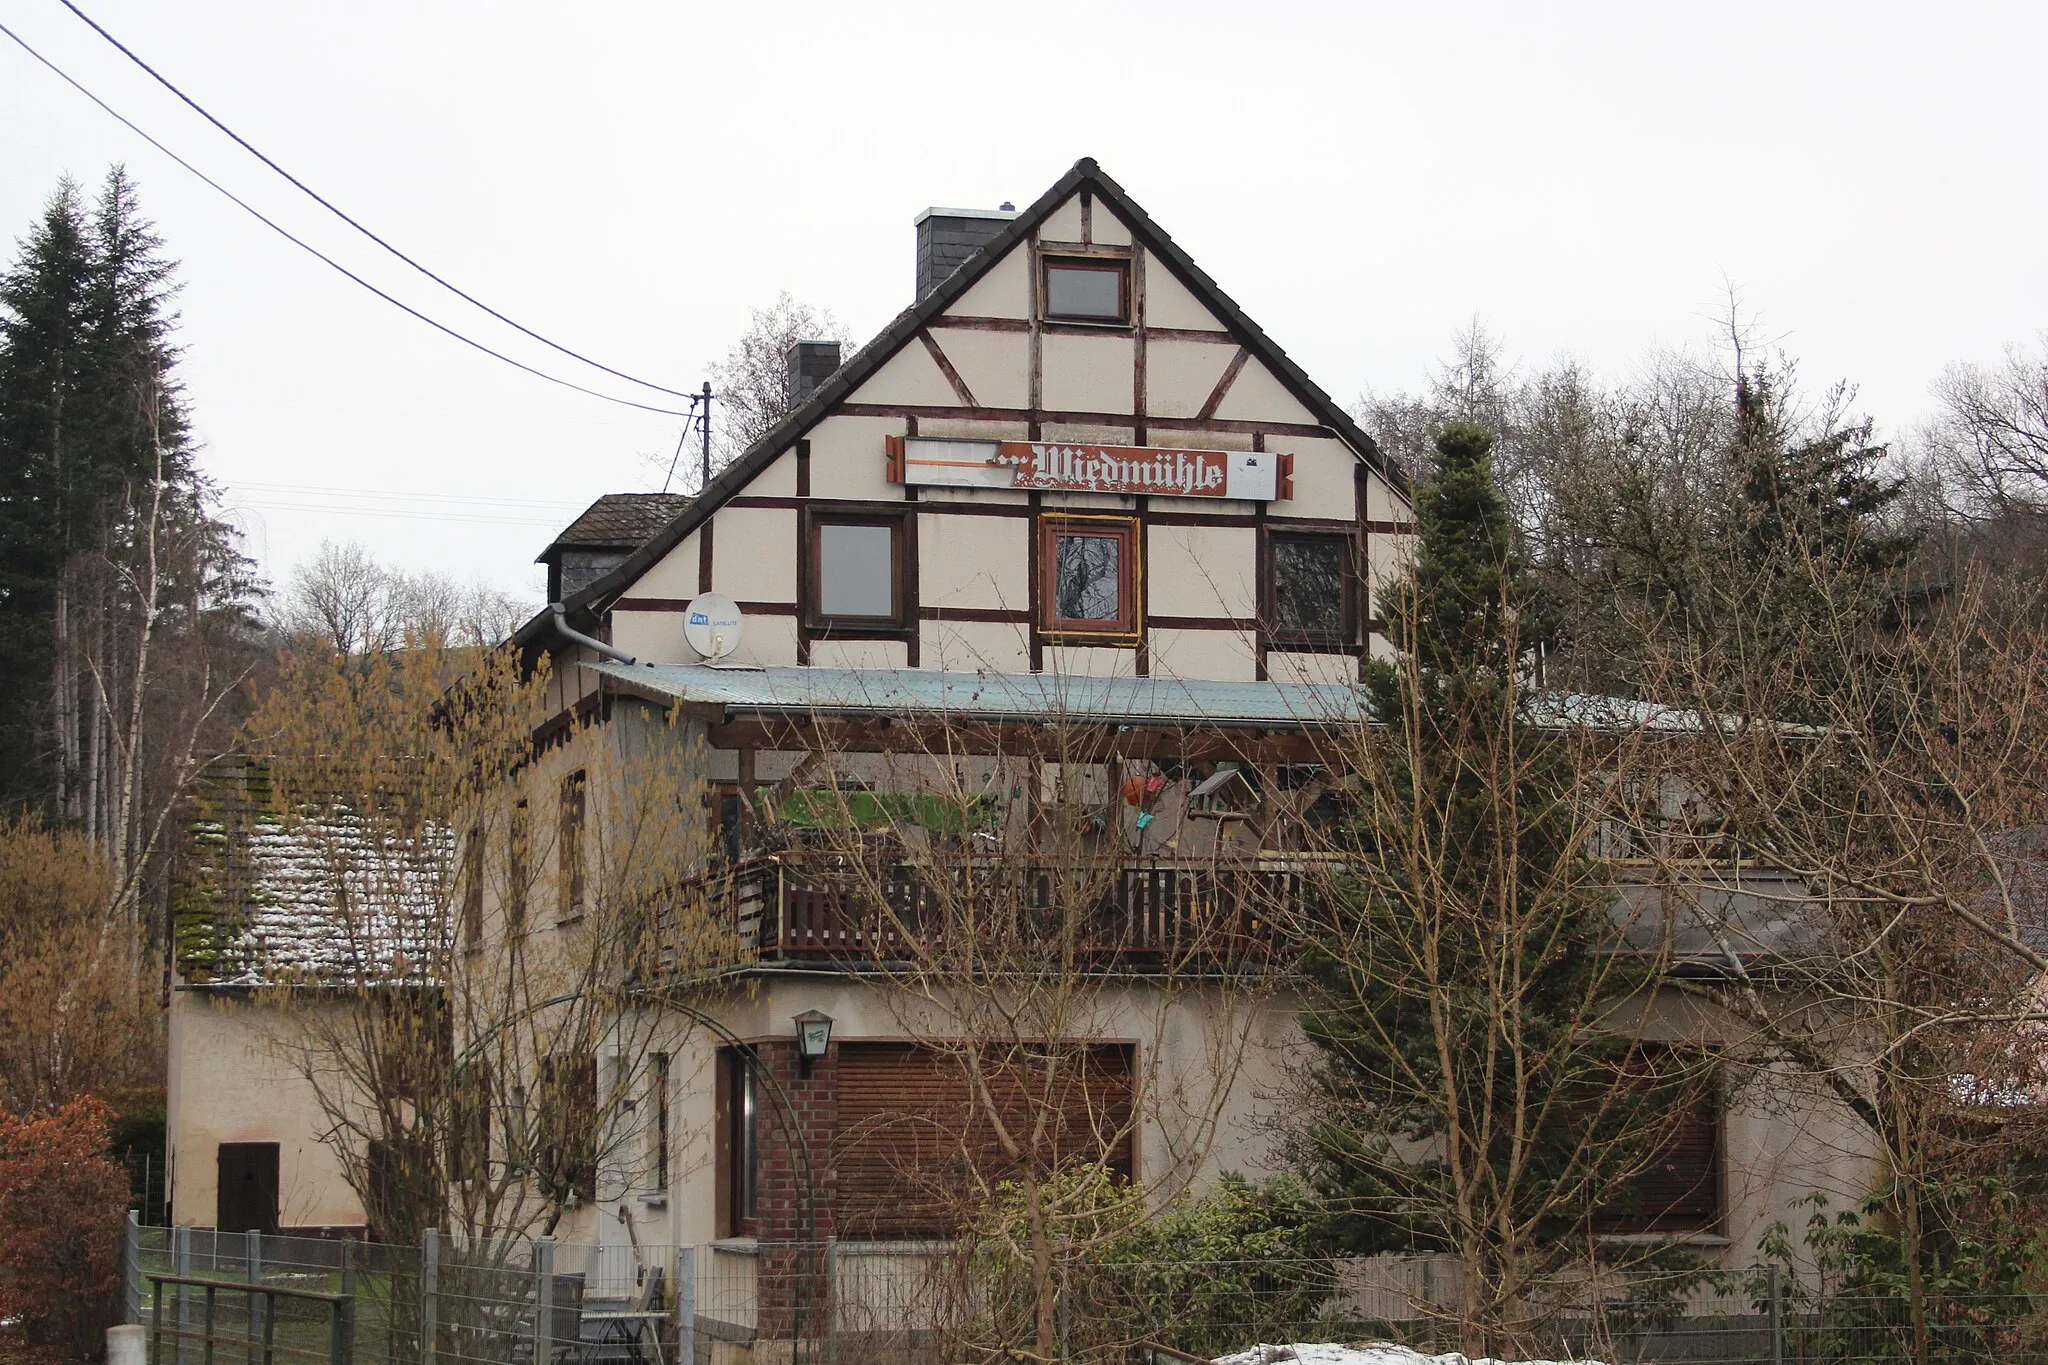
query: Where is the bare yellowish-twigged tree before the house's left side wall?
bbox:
[180,641,723,1268]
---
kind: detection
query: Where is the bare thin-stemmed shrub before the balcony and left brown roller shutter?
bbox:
[760,703,1292,1359]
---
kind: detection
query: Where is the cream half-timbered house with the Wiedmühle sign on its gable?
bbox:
[178,160,1860,1326]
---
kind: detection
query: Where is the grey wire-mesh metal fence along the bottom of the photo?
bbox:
[127,1220,2048,1365]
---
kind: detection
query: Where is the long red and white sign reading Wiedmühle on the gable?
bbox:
[889,436,1294,501]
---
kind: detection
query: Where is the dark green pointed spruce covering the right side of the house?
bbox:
[1303,424,1679,1349]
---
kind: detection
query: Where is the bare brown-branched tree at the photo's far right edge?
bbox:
[1630,540,2048,1359]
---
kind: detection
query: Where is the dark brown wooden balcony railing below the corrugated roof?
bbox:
[655,851,1329,974]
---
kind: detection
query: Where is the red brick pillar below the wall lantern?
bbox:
[754,1040,840,1336]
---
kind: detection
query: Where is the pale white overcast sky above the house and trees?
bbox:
[0,0,2048,600]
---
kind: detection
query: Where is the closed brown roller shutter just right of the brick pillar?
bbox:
[831,1042,1137,1240]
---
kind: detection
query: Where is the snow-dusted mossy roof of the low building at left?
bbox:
[178,810,457,986]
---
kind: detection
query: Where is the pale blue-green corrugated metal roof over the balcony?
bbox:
[584,663,1364,729]
